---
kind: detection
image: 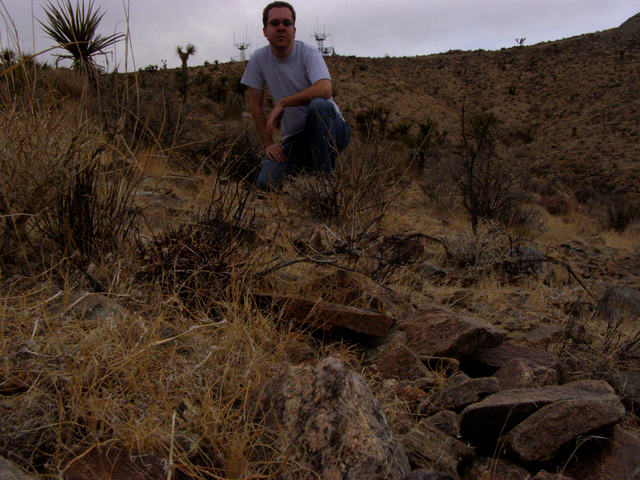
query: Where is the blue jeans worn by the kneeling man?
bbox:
[257,98,351,190]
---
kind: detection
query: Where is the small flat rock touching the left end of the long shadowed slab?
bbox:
[427,377,500,413]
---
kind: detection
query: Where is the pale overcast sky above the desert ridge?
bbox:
[0,0,640,70]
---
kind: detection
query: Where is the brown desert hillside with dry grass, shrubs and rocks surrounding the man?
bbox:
[0,9,640,480]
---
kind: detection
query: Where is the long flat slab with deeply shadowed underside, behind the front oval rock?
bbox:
[460,380,618,449]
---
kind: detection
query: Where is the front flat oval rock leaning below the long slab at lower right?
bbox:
[505,398,625,463]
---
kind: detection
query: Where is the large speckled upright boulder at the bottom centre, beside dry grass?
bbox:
[262,358,411,480]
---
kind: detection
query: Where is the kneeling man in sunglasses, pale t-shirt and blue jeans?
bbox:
[240,2,350,189]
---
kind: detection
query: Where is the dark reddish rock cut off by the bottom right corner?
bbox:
[567,426,640,480]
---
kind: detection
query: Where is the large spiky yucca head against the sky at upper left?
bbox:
[40,0,124,73]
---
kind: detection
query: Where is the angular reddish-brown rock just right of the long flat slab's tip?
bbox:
[399,307,506,360]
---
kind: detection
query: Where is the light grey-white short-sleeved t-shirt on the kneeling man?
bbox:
[240,40,340,137]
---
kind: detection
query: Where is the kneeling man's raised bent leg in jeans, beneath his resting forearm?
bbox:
[304,98,350,172]
